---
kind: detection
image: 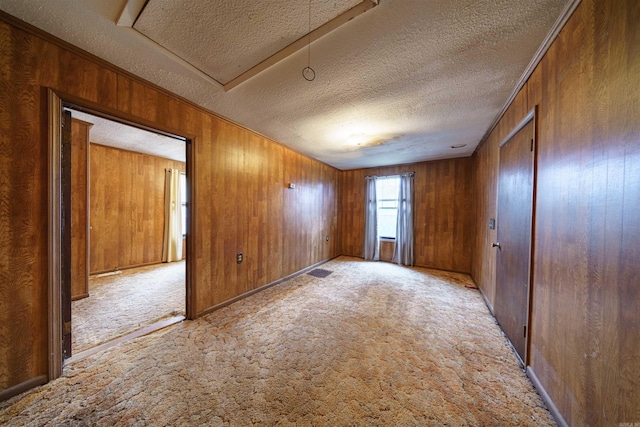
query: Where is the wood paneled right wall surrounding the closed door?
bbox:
[472,0,640,426]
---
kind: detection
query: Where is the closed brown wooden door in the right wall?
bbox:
[494,114,535,366]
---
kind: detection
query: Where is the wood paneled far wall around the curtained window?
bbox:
[341,158,474,273]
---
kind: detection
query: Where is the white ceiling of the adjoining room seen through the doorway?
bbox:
[70,109,186,162]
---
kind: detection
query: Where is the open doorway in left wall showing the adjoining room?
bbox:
[49,92,193,379]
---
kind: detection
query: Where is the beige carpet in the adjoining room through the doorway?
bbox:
[71,261,186,354]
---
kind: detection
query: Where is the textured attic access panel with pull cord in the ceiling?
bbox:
[133,0,364,85]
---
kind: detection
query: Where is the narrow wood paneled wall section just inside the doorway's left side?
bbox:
[71,119,93,300]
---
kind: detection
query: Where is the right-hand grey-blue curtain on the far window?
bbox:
[393,172,414,265]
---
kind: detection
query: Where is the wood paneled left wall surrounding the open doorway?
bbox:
[0,13,340,398]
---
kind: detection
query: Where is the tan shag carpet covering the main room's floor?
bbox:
[0,257,553,426]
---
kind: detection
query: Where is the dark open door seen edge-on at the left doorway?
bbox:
[60,110,71,359]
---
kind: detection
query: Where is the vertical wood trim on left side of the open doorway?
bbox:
[47,89,63,380]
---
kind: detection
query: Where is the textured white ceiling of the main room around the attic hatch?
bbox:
[0,0,569,169]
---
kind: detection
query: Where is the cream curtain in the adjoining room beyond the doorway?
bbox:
[162,169,182,262]
